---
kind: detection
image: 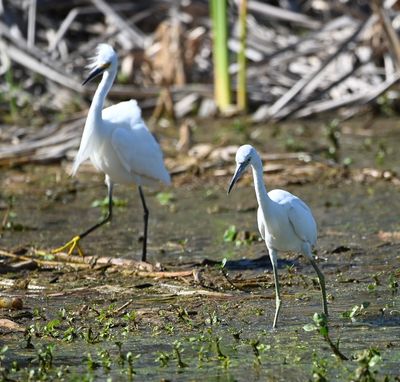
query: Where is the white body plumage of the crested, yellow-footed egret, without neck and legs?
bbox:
[72,100,171,185]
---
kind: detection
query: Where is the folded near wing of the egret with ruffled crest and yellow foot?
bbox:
[111,119,171,184]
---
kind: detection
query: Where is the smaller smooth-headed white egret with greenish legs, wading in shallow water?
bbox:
[228,145,328,328]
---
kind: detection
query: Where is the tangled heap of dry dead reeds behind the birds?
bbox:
[0,0,400,169]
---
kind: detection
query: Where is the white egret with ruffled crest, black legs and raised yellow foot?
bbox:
[53,44,171,261]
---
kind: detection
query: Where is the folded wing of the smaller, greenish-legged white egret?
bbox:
[288,197,317,245]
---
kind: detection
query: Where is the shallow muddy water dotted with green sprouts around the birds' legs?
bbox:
[0,120,400,381]
